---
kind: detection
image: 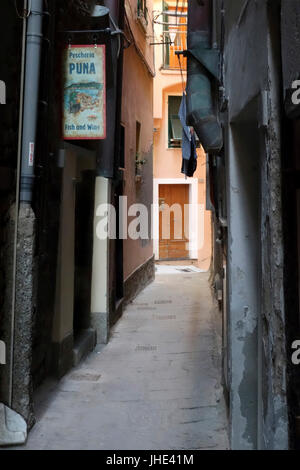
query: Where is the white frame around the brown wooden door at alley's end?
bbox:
[152,178,199,260]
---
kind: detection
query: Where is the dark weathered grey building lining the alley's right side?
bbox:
[187,0,299,450]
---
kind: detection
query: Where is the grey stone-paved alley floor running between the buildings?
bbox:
[21,266,228,450]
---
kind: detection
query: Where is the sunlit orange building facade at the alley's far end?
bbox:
[153,0,211,270]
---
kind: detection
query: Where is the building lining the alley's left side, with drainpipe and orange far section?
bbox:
[0,0,154,442]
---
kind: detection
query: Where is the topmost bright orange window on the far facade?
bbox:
[162,1,187,70]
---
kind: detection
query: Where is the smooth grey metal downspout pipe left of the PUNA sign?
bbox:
[20,0,44,204]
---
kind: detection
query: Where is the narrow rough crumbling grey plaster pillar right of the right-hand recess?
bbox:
[262,1,289,449]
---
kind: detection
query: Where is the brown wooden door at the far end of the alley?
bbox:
[159,184,189,260]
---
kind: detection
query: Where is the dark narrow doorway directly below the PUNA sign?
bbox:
[51,144,96,377]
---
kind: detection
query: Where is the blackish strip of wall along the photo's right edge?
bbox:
[281,0,300,449]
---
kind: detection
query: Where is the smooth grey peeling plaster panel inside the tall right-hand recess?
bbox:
[227,114,260,450]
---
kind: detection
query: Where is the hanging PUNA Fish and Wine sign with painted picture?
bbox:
[63,44,106,140]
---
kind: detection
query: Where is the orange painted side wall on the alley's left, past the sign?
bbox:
[122,0,154,280]
